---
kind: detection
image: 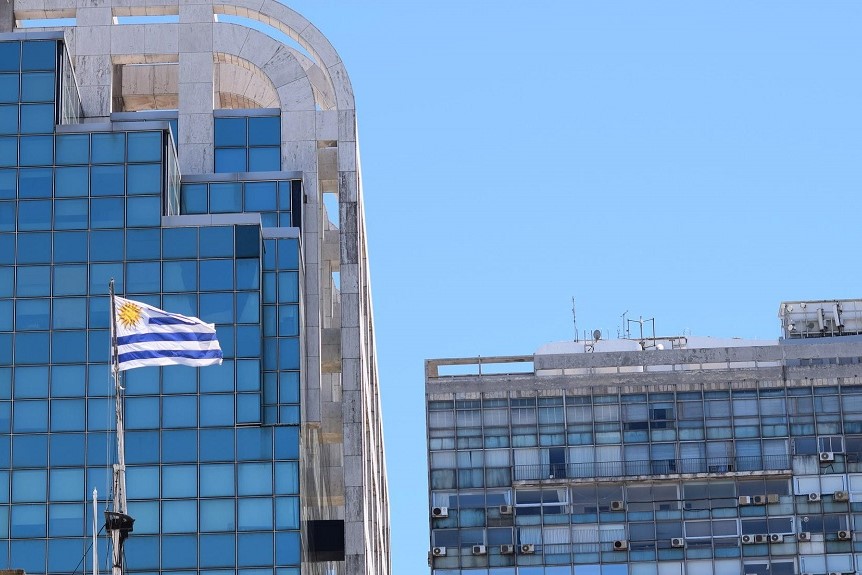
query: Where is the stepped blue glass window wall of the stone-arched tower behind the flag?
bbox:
[0,40,302,575]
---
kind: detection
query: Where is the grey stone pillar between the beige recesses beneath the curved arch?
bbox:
[178,0,214,174]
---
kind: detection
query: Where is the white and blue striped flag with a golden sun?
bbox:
[114,297,222,371]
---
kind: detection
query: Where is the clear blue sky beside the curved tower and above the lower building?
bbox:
[285,0,862,575]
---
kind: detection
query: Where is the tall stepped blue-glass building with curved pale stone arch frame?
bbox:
[0,0,389,575]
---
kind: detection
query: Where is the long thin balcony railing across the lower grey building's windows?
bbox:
[514,455,790,481]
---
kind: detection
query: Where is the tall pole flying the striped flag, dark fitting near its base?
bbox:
[105,279,134,575]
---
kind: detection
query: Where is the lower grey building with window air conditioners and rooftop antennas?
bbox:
[426,301,862,575]
